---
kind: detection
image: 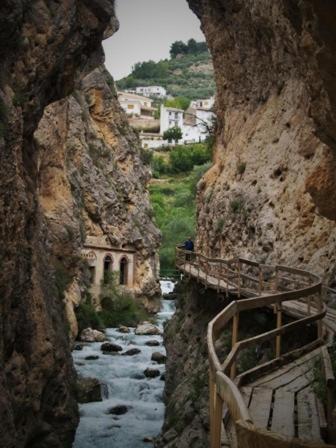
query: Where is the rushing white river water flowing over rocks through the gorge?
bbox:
[73,281,175,448]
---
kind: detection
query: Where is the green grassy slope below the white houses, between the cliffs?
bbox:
[149,144,212,275]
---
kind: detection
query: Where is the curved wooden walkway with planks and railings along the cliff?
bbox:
[176,249,336,448]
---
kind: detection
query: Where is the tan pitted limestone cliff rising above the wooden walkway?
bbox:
[189,0,336,283]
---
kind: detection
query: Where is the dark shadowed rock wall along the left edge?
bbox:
[0,0,116,448]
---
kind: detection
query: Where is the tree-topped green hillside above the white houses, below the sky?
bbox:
[117,39,215,100]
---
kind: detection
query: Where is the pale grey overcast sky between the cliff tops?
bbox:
[103,0,205,80]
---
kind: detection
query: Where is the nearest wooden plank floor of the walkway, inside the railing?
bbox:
[241,348,323,444]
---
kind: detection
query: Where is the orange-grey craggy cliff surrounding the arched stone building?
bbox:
[35,66,160,336]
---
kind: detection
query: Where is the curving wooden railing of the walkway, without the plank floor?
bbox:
[176,248,326,448]
